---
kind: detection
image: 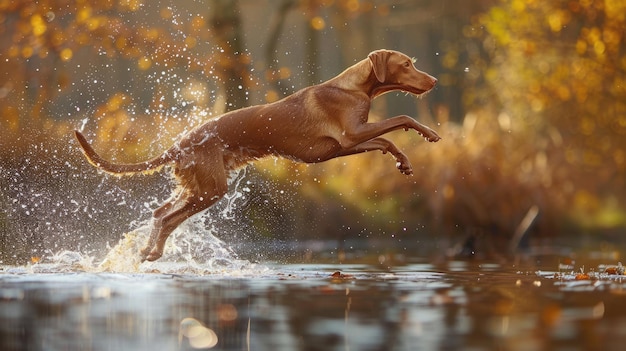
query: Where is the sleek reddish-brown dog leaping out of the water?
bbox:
[75,50,440,261]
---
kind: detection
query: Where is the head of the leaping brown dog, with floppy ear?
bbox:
[368,50,437,95]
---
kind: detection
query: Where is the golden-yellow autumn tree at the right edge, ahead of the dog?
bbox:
[466,0,626,230]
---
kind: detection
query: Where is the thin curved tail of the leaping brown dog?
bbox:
[74,130,176,175]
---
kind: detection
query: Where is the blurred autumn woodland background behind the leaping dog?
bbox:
[0,0,626,264]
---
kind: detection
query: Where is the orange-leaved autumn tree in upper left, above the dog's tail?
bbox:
[0,0,249,148]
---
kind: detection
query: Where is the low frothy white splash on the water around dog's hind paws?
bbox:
[19,213,270,276]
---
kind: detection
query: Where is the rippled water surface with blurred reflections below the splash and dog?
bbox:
[0,264,626,350]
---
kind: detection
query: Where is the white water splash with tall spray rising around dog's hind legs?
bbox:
[0,163,268,276]
